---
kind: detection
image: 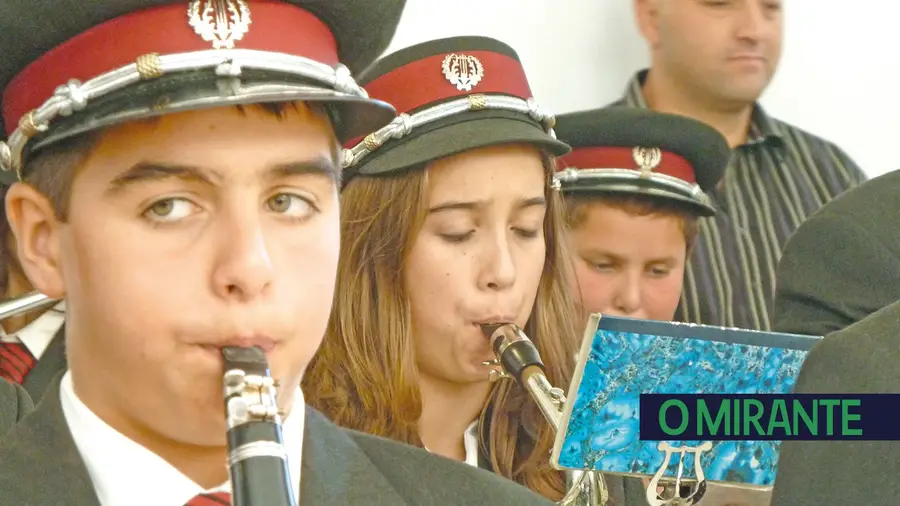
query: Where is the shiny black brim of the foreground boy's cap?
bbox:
[29,71,396,150]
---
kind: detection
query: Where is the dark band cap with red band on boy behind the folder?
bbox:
[556,106,731,216]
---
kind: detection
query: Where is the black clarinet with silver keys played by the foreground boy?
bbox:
[222,346,297,506]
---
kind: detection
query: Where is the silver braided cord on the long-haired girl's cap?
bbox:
[341,93,556,169]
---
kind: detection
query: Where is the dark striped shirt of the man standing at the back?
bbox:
[612,70,866,330]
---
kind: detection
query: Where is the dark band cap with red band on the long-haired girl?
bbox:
[344,36,569,181]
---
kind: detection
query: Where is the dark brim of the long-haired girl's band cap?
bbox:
[348,110,571,175]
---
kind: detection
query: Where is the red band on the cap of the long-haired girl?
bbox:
[365,51,531,113]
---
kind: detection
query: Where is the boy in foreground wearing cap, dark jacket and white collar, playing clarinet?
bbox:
[0,0,548,506]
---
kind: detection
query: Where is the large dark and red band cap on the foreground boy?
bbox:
[0,0,406,185]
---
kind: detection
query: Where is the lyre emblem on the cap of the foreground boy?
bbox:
[188,0,250,49]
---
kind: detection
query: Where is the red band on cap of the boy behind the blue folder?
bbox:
[558,147,697,184]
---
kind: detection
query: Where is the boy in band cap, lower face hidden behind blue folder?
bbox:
[556,107,730,326]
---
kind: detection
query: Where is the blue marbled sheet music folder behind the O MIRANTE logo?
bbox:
[552,315,820,486]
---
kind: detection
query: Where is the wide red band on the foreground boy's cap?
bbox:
[3,0,339,135]
